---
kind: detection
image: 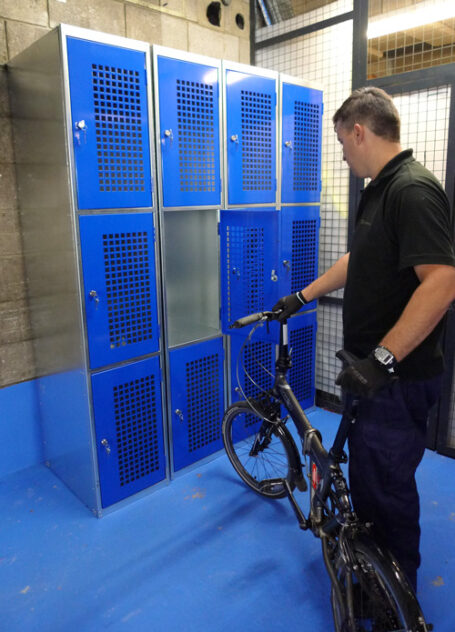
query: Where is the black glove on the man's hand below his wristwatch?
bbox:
[335,356,393,397]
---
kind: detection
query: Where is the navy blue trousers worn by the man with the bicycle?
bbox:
[348,376,441,589]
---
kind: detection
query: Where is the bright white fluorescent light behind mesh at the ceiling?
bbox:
[367,0,455,39]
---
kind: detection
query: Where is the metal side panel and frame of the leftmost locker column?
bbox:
[8,24,169,516]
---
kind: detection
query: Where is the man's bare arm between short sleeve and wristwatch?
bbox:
[380,264,455,362]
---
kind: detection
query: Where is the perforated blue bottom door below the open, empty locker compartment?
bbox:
[169,338,224,471]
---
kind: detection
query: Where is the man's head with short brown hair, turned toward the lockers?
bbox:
[333,87,401,178]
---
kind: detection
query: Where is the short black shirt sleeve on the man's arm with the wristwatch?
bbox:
[394,184,455,270]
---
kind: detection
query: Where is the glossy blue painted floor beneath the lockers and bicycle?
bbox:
[0,410,455,632]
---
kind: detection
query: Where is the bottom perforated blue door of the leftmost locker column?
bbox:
[92,356,166,507]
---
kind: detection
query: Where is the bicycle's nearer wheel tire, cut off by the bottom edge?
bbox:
[331,535,428,632]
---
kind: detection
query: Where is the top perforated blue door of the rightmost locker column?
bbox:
[281,83,323,204]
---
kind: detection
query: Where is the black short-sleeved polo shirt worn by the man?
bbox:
[343,149,455,380]
